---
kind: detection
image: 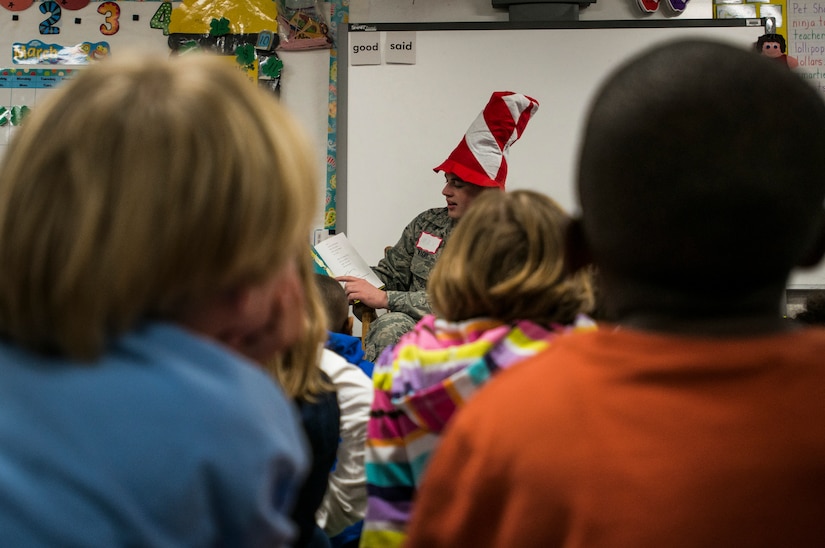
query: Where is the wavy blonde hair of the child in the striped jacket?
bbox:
[428,190,593,325]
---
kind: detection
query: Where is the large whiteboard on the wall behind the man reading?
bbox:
[336,19,780,270]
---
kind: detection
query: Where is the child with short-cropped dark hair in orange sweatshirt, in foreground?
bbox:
[407,40,825,548]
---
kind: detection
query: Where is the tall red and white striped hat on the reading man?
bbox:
[433,91,539,189]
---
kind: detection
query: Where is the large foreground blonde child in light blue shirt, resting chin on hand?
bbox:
[0,53,315,546]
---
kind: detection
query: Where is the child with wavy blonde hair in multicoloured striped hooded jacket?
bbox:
[361,190,595,547]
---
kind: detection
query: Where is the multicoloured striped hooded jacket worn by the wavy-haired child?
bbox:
[361,314,596,548]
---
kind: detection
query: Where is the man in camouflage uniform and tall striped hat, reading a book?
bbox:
[336,91,538,362]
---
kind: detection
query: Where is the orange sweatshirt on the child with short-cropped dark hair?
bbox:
[406,328,825,548]
